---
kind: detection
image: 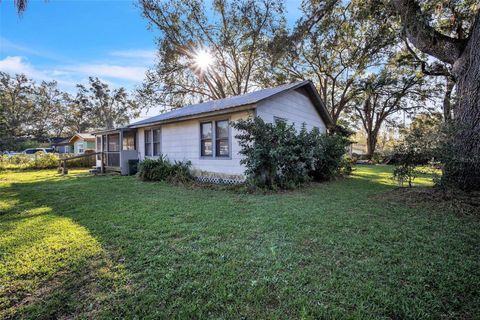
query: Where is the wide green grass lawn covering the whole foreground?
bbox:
[0,166,480,319]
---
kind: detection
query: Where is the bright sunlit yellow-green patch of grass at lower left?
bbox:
[0,171,128,319]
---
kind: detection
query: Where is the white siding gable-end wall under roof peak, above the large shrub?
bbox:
[257,89,327,133]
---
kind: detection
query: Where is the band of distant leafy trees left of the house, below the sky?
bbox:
[0,72,141,150]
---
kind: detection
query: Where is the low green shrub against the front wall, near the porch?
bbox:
[138,156,193,183]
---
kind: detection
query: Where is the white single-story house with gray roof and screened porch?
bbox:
[95,81,333,179]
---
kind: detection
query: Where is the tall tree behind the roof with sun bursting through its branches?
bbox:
[139,0,285,107]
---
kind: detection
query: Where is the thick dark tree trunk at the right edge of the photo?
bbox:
[445,15,480,191]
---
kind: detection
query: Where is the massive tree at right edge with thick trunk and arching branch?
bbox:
[391,0,480,190]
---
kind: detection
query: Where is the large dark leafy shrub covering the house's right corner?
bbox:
[232,117,347,189]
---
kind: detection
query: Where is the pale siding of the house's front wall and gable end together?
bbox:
[137,90,326,175]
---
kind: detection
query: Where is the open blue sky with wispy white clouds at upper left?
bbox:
[0,0,300,92]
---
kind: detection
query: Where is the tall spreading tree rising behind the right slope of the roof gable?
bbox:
[277,0,395,123]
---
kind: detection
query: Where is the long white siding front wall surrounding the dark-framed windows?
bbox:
[137,111,252,175]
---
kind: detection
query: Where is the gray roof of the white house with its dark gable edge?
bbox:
[128,80,333,127]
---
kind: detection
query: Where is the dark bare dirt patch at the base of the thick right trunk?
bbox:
[372,187,480,218]
